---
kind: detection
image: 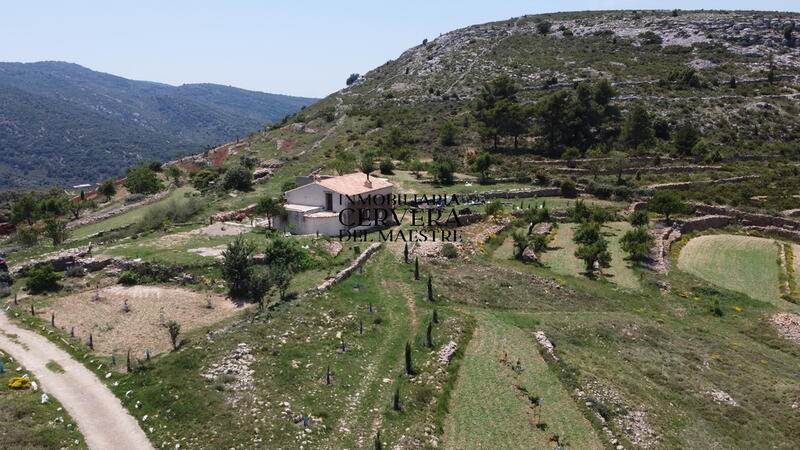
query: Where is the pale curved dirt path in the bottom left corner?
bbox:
[0,313,153,450]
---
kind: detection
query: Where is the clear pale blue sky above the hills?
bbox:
[0,0,800,97]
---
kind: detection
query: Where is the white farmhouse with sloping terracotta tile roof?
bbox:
[275,173,392,236]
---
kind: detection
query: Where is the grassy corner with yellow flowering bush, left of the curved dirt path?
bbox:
[0,352,87,449]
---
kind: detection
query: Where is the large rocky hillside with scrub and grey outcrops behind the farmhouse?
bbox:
[248,11,800,173]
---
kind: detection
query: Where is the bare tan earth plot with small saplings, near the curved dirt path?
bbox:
[43,285,240,354]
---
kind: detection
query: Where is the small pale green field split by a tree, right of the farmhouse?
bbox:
[542,222,639,289]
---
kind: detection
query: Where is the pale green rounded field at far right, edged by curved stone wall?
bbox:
[678,235,786,305]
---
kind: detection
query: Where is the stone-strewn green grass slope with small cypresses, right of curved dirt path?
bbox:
[91,250,469,448]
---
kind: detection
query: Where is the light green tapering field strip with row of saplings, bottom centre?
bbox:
[445,311,603,449]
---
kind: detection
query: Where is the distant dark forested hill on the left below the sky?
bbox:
[0,62,316,189]
